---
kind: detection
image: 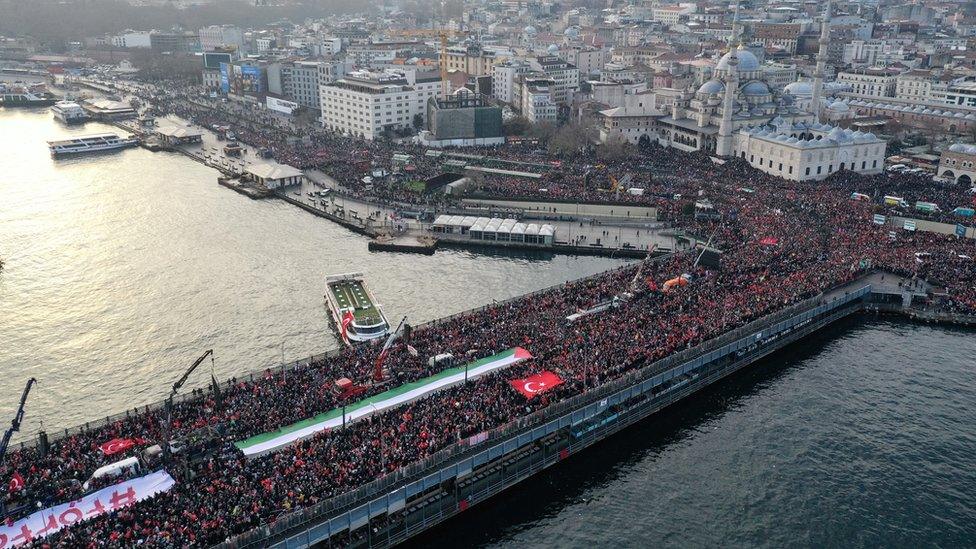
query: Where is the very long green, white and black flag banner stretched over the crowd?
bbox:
[234,347,532,457]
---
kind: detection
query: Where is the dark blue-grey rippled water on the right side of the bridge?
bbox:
[413,321,976,548]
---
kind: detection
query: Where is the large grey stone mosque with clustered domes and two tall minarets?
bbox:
[656,0,886,181]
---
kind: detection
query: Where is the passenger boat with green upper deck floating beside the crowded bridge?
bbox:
[325,273,390,345]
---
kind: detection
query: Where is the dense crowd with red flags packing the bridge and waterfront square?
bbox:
[0,76,976,547]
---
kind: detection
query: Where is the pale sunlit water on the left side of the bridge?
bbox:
[0,110,623,434]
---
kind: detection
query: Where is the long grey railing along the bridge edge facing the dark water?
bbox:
[218,285,868,549]
